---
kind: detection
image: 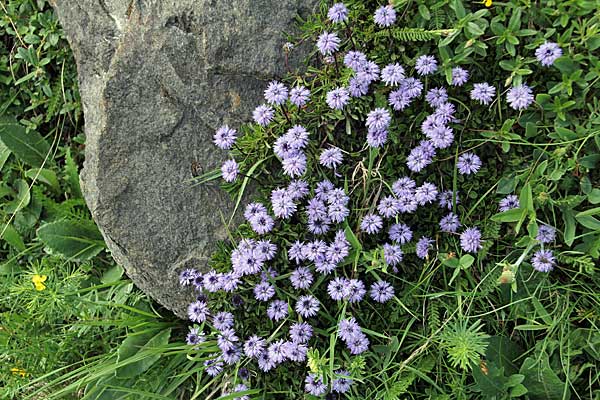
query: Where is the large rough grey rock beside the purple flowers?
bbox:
[54,0,318,317]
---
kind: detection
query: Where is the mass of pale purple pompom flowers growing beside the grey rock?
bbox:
[180,3,561,396]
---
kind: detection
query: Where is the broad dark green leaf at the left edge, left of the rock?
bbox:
[0,118,50,167]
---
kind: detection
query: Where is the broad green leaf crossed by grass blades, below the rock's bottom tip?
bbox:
[116,328,171,378]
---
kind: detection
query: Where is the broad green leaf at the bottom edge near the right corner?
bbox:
[519,353,571,400]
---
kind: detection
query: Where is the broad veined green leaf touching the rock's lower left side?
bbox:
[37,220,105,260]
